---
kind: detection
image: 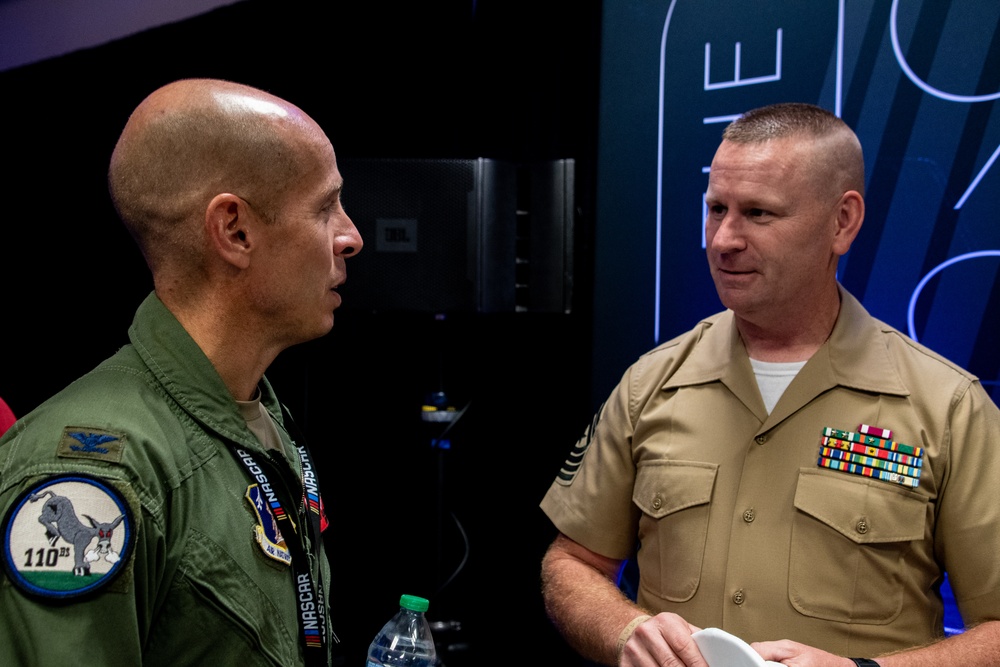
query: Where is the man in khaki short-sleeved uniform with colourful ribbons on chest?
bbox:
[541,104,1000,667]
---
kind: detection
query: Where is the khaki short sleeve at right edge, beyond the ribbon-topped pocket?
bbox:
[935,382,1000,625]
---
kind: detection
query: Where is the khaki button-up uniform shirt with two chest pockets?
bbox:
[541,290,1000,655]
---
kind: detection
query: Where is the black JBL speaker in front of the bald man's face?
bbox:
[338,158,574,314]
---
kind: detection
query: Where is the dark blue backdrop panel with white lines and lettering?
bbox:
[593,0,1000,402]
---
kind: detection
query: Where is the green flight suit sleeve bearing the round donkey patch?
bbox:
[0,471,162,665]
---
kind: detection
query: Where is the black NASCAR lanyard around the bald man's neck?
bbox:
[235,406,340,667]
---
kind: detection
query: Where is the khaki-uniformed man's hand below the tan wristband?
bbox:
[618,613,708,667]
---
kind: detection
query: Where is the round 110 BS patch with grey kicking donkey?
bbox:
[3,474,135,600]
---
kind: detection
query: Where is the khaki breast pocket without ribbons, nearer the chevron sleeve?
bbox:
[632,461,718,602]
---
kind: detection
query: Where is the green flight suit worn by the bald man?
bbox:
[0,294,330,667]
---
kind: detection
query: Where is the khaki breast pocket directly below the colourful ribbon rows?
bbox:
[788,470,927,624]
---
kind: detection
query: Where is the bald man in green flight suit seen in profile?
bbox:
[0,80,362,667]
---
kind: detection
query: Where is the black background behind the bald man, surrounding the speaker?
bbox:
[0,0,600,666]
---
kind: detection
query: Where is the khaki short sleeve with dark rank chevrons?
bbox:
[541,362,638,559]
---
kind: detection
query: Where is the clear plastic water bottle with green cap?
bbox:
[367,595,438,667]
